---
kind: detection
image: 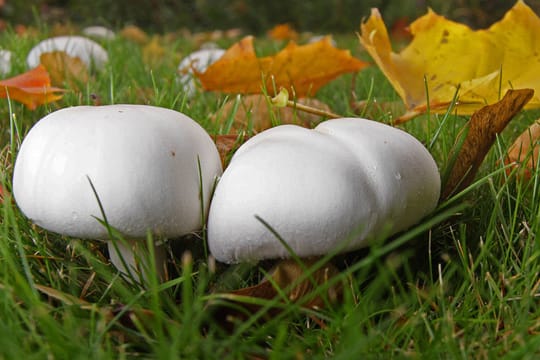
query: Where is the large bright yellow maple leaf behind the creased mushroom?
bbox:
[359,0,540,123]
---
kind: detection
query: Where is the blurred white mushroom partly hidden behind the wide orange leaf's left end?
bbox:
[178,48,225,97]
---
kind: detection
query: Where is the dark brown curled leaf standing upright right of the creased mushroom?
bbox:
[441,89,534,199]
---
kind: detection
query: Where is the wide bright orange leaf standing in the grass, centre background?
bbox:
[195,36,368,97]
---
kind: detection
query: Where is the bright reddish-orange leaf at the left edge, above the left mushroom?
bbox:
[0,65,64,110]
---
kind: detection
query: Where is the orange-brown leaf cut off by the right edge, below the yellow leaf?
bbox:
[505,119,540,180]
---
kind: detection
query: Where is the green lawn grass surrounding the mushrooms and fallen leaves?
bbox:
[0,26,540,359]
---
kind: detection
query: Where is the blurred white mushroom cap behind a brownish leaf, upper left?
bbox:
[26,36,109,69]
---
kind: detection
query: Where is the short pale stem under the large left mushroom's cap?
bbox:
[107,239,167,284]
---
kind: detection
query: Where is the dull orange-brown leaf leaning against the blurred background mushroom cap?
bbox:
[39,51,89,90]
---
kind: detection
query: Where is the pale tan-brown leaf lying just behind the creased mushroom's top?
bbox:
[214,94,330,134]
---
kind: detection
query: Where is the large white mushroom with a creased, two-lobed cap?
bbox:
[208,118,440,263]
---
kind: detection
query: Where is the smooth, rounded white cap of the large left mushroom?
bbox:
[13,105,222,239]
